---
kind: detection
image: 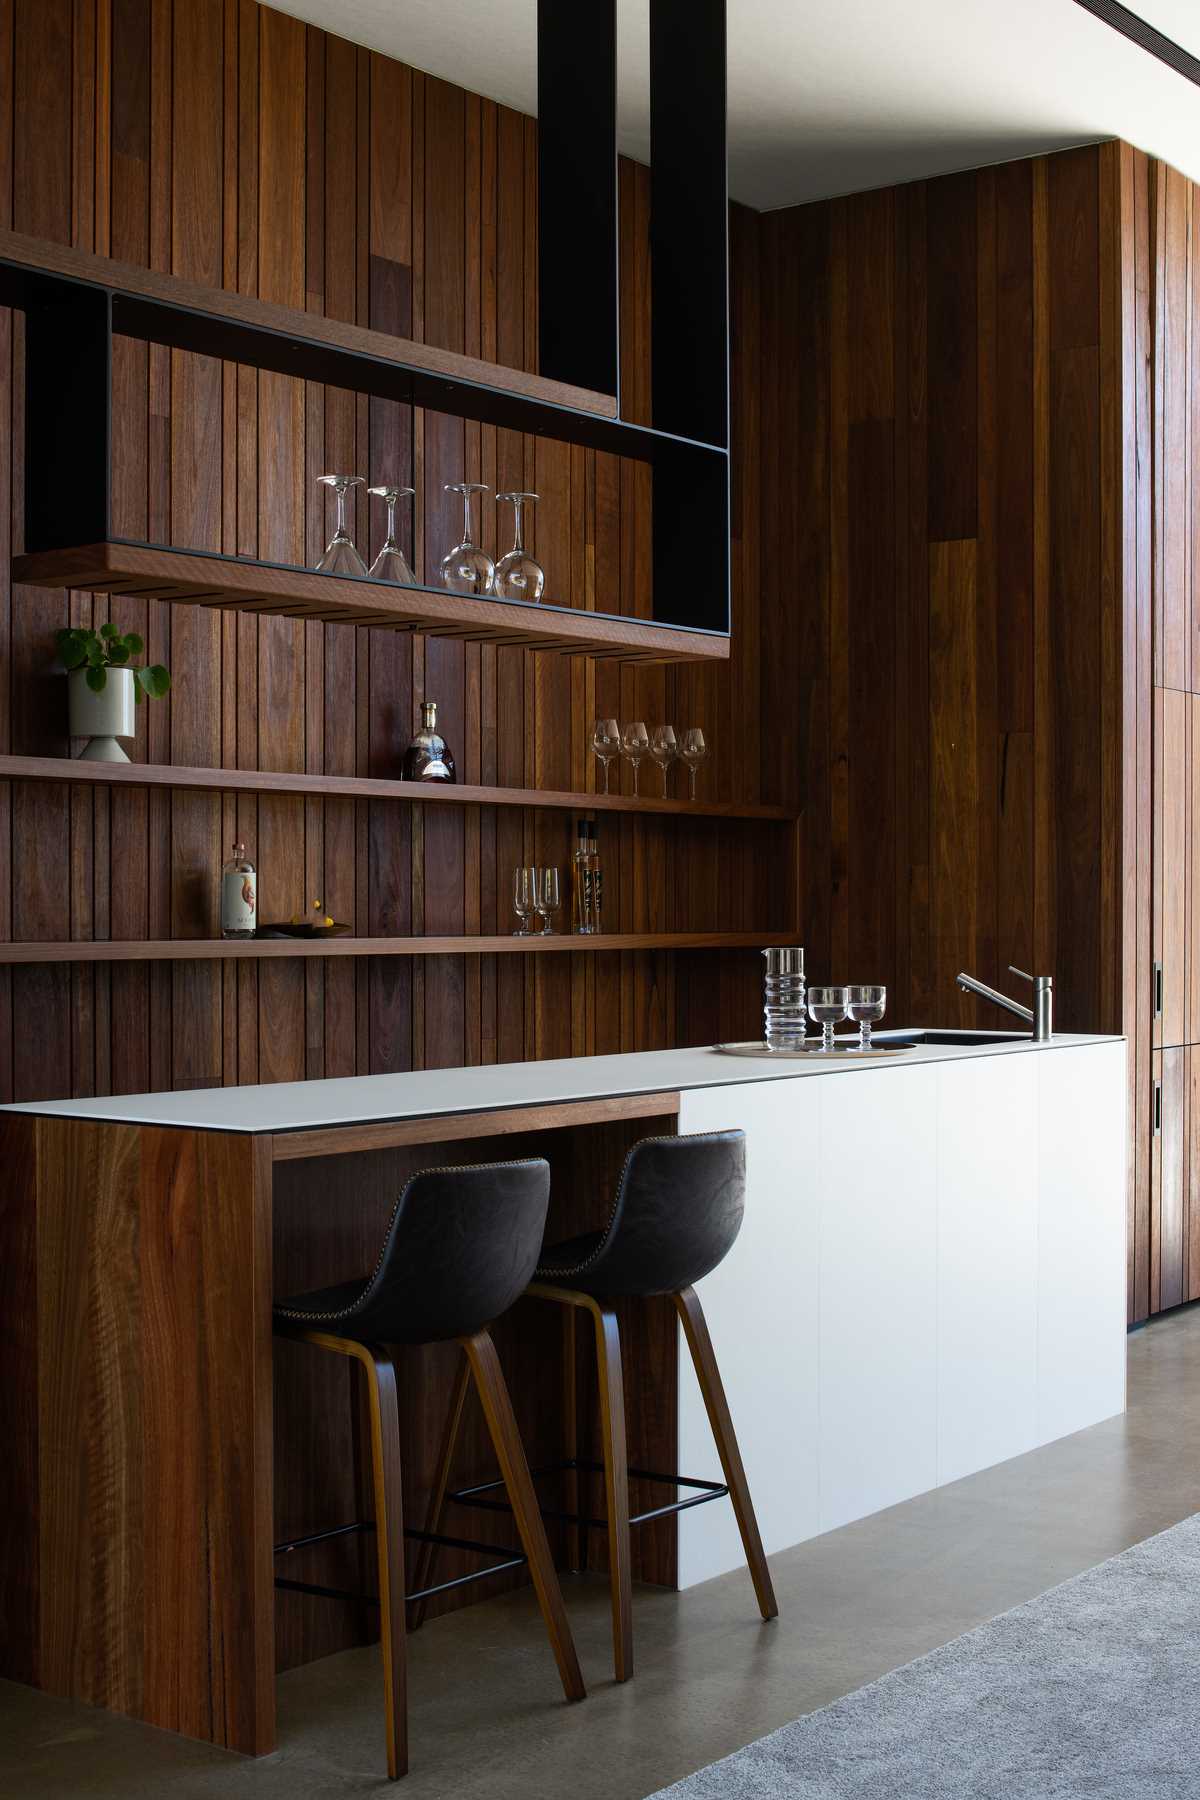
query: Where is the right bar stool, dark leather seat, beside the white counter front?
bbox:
[422,1130,779,1681]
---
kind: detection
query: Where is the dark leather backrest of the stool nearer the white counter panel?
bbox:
[561,1130,747,1296]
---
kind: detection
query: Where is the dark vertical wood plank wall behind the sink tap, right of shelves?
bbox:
[761,144,1151,1318]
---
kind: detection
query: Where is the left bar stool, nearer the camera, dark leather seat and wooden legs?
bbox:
[275,1157,585,1778]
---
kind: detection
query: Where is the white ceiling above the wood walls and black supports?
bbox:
[268,0,1200,207]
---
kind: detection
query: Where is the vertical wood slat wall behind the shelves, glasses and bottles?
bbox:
[0,0,793,1100]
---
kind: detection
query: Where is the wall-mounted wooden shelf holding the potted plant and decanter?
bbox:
[0,756,797,823]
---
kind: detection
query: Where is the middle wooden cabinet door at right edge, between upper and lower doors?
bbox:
[1151,688,1200,1048]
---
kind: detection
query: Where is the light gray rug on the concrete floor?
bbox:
[655,1514,1200,1800]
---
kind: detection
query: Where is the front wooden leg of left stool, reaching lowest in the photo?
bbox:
[358,1345,408,1780]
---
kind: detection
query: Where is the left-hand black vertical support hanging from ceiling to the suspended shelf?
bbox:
[538,0,617,394]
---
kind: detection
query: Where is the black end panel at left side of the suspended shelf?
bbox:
[25,283,112,554]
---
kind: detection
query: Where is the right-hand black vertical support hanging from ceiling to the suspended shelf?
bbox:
[649,0,729,448]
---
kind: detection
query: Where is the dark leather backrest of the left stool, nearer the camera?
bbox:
[332,1156,551,1343]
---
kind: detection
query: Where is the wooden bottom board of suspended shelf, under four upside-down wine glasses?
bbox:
[13,538,729,662]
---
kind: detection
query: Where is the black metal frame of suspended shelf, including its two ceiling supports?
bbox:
[0,0,730,635]
